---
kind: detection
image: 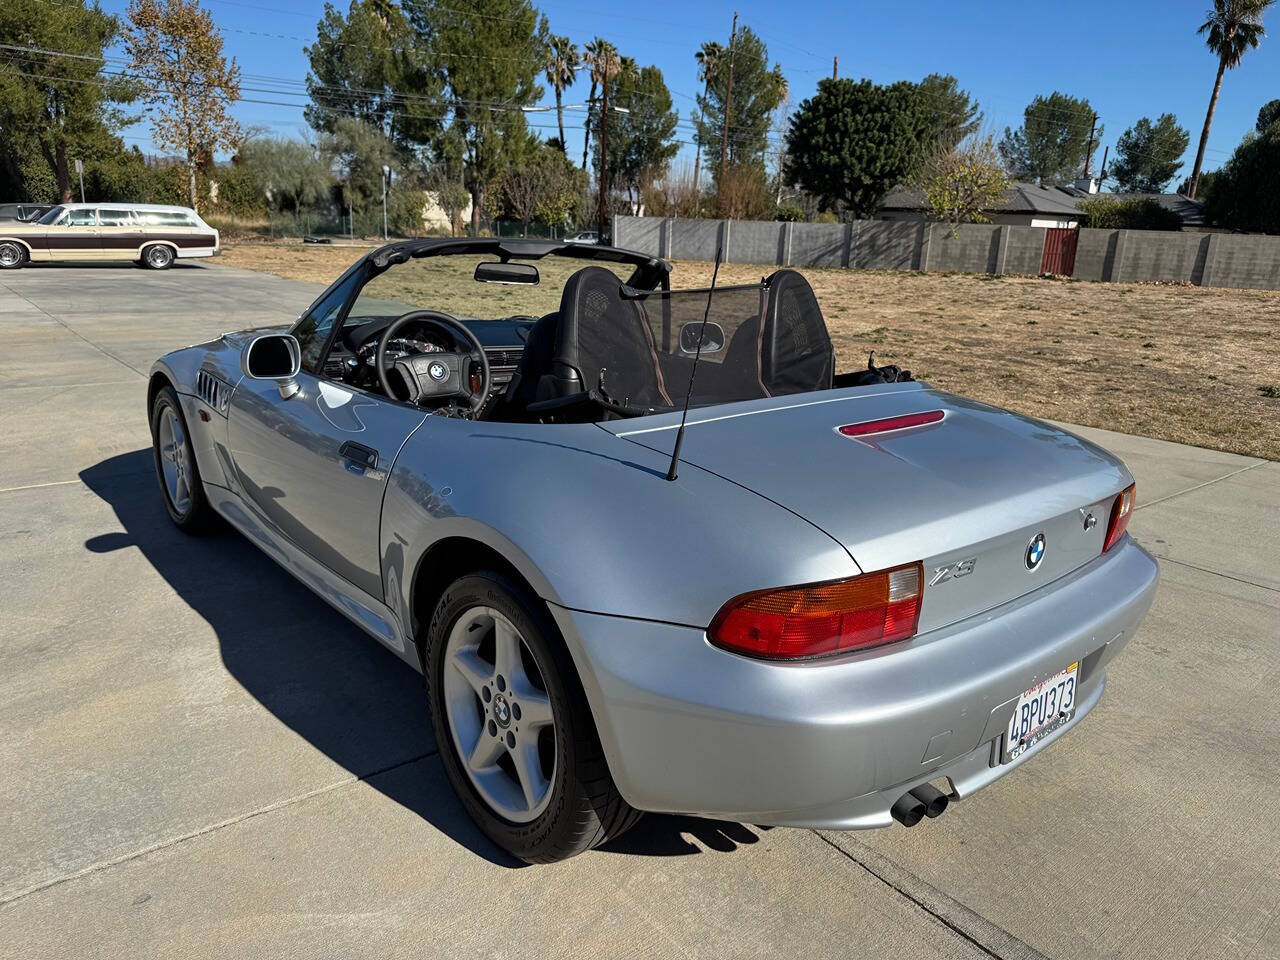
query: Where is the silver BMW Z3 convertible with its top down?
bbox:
[148,238,1157,861]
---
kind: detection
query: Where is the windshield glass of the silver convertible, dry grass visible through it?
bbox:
[346,253,635,326]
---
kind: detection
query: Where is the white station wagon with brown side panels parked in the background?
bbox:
[0,204,221,270]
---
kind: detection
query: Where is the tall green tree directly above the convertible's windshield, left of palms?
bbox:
[406,0,548,232]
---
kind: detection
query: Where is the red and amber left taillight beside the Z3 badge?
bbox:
[707,563,923,659]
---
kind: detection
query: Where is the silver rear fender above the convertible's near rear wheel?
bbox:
[381,417,860,627]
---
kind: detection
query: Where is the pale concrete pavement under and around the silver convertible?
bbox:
[0,266,1280,960]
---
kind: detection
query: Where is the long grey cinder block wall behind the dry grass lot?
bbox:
[613,216,1280,289]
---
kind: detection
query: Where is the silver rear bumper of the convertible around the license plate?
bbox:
[552,538,1158,829]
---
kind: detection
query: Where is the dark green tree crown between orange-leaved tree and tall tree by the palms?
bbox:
[303,0,442,150]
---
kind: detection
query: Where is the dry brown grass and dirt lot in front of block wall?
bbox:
[221,243,1280,460]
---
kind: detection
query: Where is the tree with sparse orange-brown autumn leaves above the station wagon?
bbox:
[124,0,239,210]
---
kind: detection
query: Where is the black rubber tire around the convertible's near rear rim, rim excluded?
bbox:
[424,571,641,863]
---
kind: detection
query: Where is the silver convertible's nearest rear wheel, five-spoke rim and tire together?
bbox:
[424,572,640,863]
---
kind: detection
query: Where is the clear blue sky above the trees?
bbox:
[102,0,1280,186]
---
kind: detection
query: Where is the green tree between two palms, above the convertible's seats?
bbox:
[590,58,680,204]
